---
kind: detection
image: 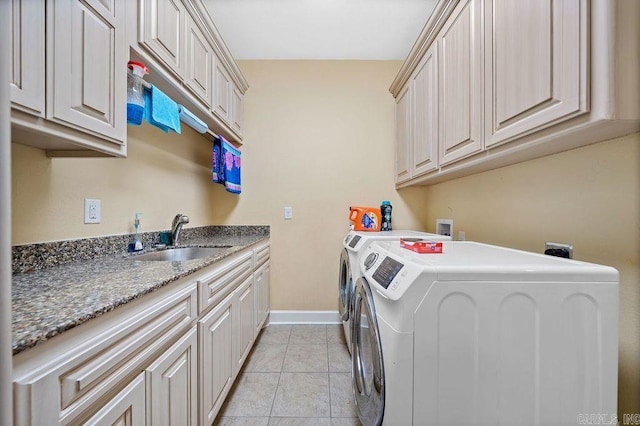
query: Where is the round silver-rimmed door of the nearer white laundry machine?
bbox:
[351,277,385,426]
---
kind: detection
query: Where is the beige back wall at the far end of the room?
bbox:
[214,61,424,310]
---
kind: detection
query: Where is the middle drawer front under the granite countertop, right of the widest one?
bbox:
[198,252,253,313]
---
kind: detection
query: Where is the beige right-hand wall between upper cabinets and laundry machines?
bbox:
[425,134,640,421]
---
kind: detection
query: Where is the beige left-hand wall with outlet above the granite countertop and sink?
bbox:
[12,125,222,244]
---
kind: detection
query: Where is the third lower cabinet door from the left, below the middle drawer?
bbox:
[198,293,235,425]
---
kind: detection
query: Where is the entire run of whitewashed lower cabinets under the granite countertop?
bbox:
[13,244,269,426]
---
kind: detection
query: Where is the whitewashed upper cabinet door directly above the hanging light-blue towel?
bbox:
[140,0,187,77]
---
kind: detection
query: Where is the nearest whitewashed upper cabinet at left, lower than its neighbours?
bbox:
[10,0,128,157]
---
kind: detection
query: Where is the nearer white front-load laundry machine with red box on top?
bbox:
[351,241,619,426]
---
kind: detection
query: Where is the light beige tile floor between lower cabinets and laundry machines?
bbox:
[214,325,360,426]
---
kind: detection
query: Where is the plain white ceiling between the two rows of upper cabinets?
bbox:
[205,0,437,60]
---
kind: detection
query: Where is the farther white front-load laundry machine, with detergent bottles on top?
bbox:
[338,230,451,350]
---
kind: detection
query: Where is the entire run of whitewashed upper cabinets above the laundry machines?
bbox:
[389,0,640,187]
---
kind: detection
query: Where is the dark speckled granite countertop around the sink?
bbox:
[12,227,269,355]
